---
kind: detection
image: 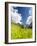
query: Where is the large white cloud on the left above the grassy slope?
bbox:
[11,8,22,24]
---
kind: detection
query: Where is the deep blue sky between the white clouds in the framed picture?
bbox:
[14,7,32,24]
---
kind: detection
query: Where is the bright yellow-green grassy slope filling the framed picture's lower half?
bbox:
[11,24,32,39]
